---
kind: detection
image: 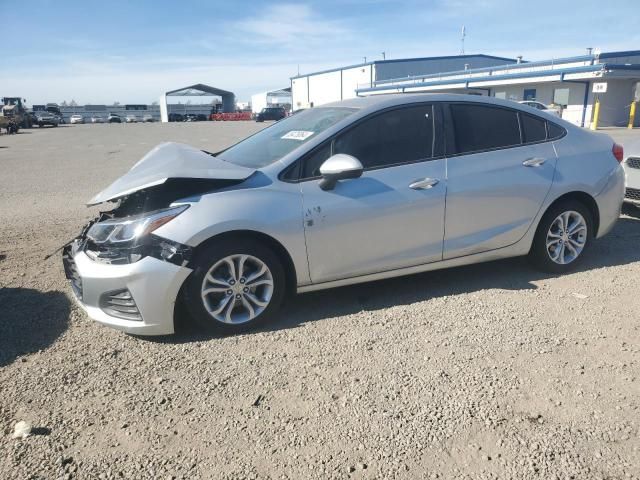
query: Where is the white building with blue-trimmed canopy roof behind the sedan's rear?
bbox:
[357,50,640,127]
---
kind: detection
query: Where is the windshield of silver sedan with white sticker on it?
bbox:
[218,107,357,168]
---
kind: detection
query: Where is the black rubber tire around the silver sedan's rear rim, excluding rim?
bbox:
[529,200,594,273]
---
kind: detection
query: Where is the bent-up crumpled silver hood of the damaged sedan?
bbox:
[87,142,255,206]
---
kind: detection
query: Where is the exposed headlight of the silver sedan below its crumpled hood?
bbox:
[84,205,189,264]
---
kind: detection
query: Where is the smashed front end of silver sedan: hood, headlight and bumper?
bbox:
[62,143,254,335]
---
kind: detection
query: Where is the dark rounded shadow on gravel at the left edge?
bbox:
[0,287,71,367]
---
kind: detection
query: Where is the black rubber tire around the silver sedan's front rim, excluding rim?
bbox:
[183,238,287,334]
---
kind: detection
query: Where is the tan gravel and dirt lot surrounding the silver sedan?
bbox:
[0,122,640,480]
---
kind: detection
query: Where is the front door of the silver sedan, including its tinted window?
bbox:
[301,104,446,283]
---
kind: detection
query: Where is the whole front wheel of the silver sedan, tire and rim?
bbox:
[184,239,286,333]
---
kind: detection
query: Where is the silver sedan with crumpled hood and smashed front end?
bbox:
[63,94,624,335]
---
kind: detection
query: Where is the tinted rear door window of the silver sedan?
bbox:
[451,103,520,153]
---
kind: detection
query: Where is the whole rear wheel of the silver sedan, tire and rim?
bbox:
[529,200,594,273]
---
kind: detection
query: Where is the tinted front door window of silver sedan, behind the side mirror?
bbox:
[333,105,434,168]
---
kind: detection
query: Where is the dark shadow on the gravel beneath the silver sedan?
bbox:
[156,215,640,343]
